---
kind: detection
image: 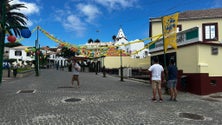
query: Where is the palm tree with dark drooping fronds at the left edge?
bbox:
[0,0,28,83]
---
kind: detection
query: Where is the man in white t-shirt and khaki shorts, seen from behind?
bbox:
[148,58,165,102]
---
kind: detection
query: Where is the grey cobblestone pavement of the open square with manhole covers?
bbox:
[0,69,222,125]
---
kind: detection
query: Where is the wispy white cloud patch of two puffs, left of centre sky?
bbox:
[55,3,100,37]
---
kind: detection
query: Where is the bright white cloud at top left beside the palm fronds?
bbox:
[10,0,39,15]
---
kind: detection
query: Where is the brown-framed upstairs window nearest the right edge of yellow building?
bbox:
[203,23,218,41]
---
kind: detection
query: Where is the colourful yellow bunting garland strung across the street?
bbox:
[17,26,163,58]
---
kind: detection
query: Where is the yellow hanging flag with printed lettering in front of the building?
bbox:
[162,13,179,52]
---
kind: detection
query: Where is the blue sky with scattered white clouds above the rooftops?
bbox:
[7,0,222,47]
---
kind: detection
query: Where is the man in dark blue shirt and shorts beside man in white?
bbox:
[167,59,178,101]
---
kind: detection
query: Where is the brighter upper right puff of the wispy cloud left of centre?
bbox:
[77,4,100,22]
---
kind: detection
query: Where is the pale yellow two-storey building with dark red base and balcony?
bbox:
[149,8,222,95]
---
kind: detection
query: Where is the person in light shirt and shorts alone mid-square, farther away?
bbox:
[72,60,81,88]
